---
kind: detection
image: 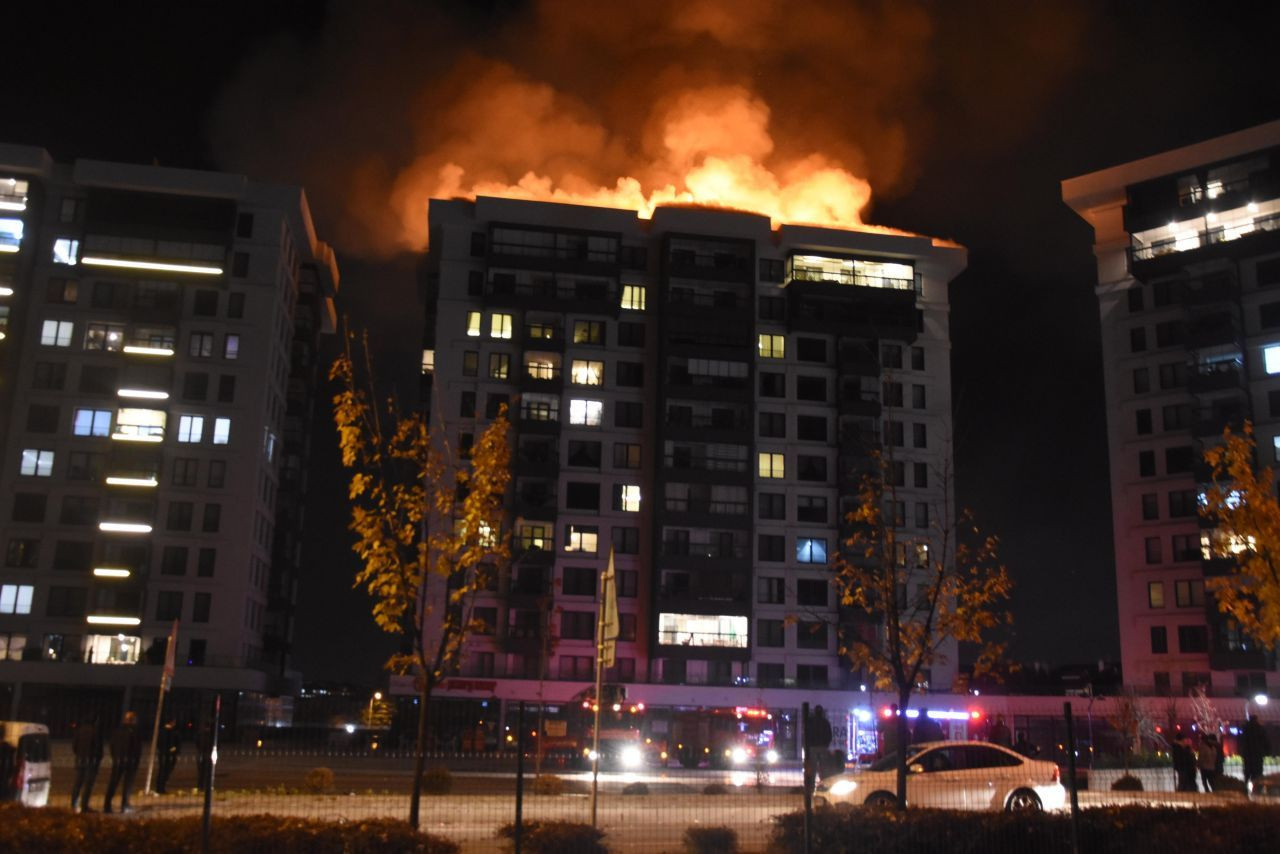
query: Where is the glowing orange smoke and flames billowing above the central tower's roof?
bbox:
[211,0,1078,256]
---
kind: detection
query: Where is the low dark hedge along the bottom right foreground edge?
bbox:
[767,804,1280,854]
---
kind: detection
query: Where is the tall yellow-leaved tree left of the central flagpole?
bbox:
[329,334,511,827]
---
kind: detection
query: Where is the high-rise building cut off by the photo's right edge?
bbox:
[1062,122,1280,695]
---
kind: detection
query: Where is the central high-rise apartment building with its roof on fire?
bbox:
[422,197,965,708]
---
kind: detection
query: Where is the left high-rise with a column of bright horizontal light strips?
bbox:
[0,146,338,725]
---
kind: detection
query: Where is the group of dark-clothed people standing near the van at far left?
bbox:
[72,712,197,813]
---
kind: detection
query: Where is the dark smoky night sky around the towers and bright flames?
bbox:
[0,0,1280,685]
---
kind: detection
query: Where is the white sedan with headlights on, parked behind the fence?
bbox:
[824,741,1066,812]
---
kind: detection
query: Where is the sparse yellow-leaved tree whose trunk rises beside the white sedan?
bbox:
[835,452,1012,809]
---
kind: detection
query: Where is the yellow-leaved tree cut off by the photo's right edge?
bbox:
[1201,421,1280,649]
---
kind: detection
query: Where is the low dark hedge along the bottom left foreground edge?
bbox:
[0,804,461,854]
